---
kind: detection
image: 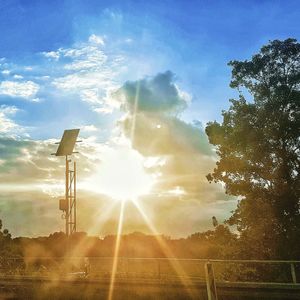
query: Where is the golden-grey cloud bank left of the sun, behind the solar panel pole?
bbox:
[0,137,145,236]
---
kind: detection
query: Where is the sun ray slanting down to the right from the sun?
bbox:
[132,200,197,298]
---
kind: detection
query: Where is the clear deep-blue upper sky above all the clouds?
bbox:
[0,0,300,132]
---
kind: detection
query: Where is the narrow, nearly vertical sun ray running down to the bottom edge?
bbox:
[108,200,125,300]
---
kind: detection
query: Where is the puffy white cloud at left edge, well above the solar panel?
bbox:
[0,80,39,100]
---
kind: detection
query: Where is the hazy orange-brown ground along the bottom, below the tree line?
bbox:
[0,258,300,300]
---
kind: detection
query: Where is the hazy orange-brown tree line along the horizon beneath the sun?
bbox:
[1,225,237,258]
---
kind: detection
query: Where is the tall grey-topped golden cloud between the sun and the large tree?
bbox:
[115,71,225,203]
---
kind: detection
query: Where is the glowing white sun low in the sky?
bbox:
[85,146,154,200]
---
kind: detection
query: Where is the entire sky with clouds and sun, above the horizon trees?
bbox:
[0,0,300,237]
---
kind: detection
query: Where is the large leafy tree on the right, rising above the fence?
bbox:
[206,39,300,258]
